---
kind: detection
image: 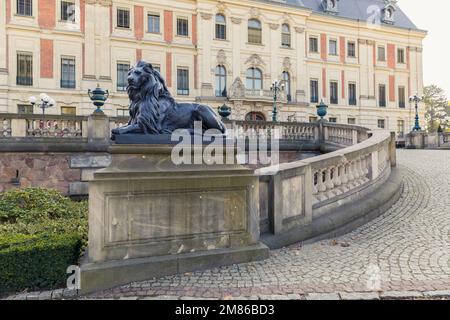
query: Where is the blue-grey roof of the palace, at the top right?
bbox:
[277,0,419,30]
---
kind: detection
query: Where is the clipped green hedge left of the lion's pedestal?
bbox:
[0,188,88,294]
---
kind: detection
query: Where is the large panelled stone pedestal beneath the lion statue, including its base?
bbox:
[81,145,268,293]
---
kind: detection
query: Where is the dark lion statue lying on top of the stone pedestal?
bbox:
[112,61,226,139]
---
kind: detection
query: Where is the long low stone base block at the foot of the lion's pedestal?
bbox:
[80,244,269,294]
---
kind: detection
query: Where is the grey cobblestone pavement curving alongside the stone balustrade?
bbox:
[4,150,450,299]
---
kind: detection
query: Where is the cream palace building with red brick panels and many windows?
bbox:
[0,0,426,137]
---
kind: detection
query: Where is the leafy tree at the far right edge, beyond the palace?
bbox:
[423,84,450,132]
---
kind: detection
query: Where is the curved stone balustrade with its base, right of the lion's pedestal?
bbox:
[256,127,401,248]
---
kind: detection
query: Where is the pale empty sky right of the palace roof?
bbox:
[398,0,450,98]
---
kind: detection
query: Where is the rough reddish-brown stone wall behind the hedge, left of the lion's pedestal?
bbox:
[0,153,81,195]
